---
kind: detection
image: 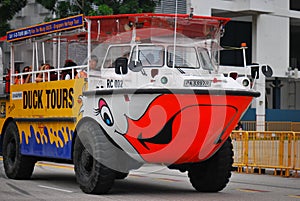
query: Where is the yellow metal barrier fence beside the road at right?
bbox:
[231,131,300,176]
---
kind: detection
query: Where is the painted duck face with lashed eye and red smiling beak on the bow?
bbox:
[96,94,237,163]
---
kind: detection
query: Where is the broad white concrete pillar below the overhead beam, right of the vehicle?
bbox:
[252,14,290,77]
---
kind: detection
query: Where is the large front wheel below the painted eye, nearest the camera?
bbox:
[73,121,116,194]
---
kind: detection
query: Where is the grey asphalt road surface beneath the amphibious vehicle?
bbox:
[0,157,300,201]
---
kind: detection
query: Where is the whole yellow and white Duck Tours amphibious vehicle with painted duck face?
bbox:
[0,13,259,194]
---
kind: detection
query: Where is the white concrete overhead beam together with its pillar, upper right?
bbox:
[189,0,290,77]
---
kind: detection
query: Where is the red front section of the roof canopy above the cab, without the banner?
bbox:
[86,13,229,41]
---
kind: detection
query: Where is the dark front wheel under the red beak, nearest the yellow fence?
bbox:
[188,138,233,192]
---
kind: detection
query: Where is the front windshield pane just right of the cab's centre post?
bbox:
[167,46,200,68]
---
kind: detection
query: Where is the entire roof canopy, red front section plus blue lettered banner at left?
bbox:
[7,13,229,42]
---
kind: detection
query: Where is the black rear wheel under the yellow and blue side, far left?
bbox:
[3,122,36,179]
